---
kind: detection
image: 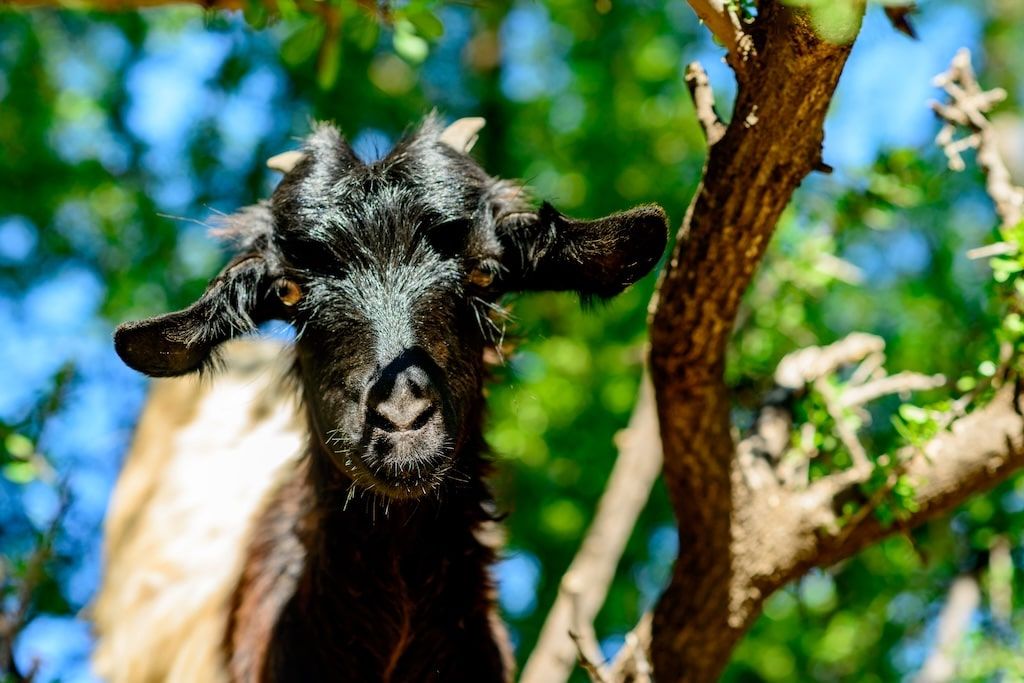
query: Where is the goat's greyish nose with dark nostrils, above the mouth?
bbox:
[367,366,436,432]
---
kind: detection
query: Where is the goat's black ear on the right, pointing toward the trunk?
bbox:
[499,202,668,298]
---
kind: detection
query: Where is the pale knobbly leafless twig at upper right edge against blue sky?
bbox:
[932,48,1024,227]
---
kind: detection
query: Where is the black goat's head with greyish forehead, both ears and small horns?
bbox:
[115,118,666,498]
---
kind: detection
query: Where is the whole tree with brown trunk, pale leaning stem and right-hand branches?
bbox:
[2,0,1024,681]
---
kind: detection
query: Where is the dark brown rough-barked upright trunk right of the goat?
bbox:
[650,2,850,682]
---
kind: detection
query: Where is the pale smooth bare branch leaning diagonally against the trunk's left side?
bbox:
[519,373,662,683]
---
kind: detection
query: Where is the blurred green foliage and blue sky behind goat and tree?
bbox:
[0,0,1024,681]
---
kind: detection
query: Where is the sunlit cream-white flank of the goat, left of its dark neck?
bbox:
[92,341,305,683]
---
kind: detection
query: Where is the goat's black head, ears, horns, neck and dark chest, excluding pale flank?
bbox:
[96,116,667,682]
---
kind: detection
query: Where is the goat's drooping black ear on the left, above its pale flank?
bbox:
[114,255,270,377]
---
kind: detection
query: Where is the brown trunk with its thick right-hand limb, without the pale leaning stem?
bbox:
[527,1,1024,681]
